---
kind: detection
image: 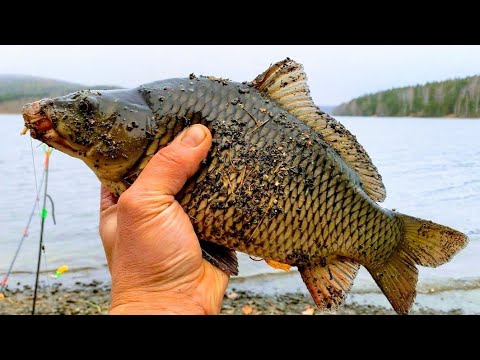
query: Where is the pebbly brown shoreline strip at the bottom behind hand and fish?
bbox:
[0,280,462,315]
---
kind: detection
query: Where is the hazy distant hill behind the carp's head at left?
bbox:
[0,75,116,113]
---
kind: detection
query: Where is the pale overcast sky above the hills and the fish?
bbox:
[0,45,480,105]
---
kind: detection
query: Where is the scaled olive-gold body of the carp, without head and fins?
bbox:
[132,79,401,266]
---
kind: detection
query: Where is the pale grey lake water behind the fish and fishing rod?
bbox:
[0,115,480,312]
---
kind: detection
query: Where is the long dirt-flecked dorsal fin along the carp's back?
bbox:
[253,58,386,201]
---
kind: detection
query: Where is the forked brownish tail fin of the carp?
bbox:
[370,214,468,314]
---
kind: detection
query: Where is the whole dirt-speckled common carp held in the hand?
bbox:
[23,58,468,314]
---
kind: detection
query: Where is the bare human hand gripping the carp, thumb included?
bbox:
[100,125,229,314]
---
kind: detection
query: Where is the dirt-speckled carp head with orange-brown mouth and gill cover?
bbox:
[22,89,153,193]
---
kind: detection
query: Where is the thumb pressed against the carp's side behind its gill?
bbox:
[126,124,212,197]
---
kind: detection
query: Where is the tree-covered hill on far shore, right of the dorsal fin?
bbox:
[333,75,480,117]
